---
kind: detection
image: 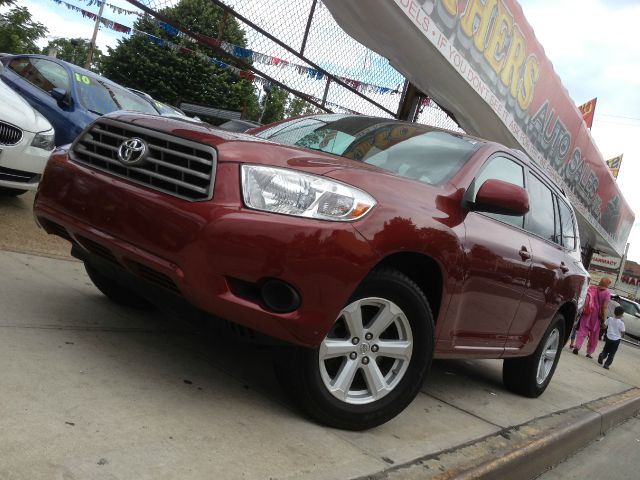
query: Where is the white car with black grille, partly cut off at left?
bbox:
[0,64,55,196]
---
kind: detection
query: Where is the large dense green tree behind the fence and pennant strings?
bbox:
[102,0,258,115]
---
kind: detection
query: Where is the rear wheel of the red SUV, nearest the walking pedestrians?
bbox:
[502,313,566,398]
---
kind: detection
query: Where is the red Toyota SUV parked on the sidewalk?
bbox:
[35,113,587,430]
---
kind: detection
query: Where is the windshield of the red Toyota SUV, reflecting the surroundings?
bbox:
[256,115,479,185]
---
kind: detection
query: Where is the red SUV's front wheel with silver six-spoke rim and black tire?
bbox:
[276,269,434,430]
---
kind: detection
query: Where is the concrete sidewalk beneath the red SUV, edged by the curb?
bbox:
[0,251,640,480]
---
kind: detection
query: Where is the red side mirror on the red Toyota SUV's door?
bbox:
[470,178,529,215]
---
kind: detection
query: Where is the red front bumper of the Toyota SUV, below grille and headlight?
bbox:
[34,152,379,346]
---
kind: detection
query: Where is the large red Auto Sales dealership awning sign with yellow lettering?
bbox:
[324,0,634,255]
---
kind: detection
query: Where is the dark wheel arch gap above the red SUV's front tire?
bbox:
[375,252,444,323]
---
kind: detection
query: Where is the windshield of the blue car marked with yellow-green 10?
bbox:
[76,74,158,115]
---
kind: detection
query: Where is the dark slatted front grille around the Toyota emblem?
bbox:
[71,118,216,201]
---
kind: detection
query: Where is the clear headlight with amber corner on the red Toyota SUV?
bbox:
[242,165,376,222]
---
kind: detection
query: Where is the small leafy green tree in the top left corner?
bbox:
[0,6,49,53]
